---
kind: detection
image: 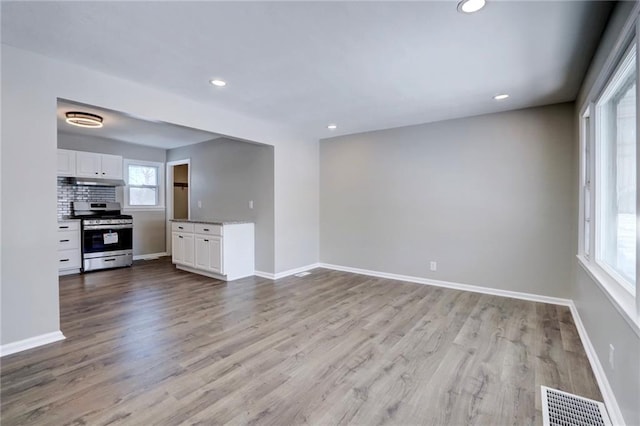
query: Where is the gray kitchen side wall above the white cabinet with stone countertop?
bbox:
[167,138,274,273]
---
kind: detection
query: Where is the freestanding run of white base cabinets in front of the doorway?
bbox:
[171,222,254,281]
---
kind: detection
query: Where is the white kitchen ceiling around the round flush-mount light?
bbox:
[57,100,221,149]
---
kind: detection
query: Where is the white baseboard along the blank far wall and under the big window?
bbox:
[318,263,625,425]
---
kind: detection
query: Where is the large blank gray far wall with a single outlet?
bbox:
[320,103,575,297]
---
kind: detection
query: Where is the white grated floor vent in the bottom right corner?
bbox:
[540,386,612,426]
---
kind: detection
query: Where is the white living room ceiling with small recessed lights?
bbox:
[2,0,612,138]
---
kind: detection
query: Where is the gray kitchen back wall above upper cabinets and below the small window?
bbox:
[58,132,167,256]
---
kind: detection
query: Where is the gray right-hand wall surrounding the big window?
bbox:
[569,2,640,425]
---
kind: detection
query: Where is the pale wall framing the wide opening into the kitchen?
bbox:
[0,45,318,345]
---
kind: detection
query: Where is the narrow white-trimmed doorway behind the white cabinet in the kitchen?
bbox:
[166,159,191,254]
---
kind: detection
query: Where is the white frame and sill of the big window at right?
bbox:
[577,30,640,335]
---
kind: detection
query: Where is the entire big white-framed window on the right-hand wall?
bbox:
[578,40,640,327]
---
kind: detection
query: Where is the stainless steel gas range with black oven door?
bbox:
[73,201,133,272]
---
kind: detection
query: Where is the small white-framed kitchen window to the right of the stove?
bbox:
[124,159,164,210]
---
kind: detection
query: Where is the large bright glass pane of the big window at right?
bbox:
[598,47,636,286]
